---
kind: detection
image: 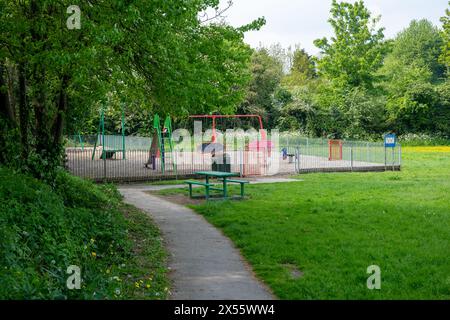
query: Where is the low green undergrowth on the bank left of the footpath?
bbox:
[0,167,167,299]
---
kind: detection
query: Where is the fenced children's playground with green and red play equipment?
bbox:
[66,112,402,182]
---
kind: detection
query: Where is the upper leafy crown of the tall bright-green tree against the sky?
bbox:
[314,0,385,88]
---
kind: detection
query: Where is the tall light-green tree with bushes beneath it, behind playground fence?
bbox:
[314,0,386,138]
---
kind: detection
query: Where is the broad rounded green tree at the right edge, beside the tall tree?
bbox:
[380,20,450,134]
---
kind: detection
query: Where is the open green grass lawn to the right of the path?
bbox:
[158,148,450,299]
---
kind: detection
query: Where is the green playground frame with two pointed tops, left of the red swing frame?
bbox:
[145,114,177,174]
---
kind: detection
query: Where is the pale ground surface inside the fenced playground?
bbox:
[66,147,400,182]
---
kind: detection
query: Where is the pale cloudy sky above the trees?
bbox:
[216,0,449,55]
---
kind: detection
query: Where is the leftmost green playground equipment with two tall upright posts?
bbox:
[92,107,126,160]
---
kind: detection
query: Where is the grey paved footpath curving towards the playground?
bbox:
[119,179,299,300]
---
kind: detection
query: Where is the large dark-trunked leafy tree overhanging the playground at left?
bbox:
[0,0,264,180]
